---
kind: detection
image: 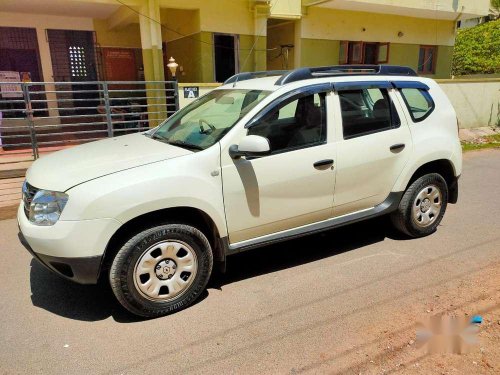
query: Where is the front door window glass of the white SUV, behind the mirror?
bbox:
[248,93,326,153]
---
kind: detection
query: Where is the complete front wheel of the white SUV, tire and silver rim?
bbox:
[109,224,213,317]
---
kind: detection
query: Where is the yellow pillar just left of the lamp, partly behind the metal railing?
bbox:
[139,0,166,127]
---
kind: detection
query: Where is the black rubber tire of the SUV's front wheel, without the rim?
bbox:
[109,224,213,318]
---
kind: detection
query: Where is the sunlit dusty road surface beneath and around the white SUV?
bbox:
[0,150,500,374]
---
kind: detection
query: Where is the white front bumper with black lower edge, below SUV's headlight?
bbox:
[17,204,120,284]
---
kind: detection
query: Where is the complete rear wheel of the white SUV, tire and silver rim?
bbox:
[391,173,448,237]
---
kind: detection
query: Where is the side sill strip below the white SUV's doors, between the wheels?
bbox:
[225,191,404,255]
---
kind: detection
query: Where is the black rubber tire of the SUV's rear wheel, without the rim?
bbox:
[391,173,448,237]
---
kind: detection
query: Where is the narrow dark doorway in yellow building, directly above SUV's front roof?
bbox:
[214,34,239,82]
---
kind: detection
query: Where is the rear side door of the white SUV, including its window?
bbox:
[333,81,412,216]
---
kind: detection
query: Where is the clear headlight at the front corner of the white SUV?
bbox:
[29,190,68,225]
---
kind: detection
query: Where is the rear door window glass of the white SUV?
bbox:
[339,88,399,139]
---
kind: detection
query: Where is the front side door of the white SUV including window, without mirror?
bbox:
[221,84,335,244]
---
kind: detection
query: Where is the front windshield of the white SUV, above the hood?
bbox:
[150,89,270,150]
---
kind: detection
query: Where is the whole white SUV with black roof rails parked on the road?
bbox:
[18,65,462,317]
